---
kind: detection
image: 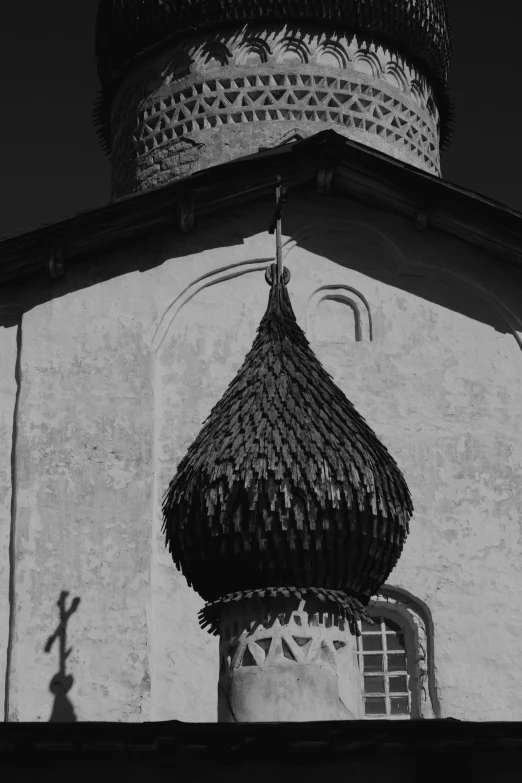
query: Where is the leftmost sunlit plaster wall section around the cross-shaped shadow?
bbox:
[10,277,152,721]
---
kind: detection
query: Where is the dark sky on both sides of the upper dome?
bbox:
[0,0,522,236]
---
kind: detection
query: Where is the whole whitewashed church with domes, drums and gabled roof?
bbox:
[0,0,522,736]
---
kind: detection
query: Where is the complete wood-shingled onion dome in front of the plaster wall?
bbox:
[163,275,413,605]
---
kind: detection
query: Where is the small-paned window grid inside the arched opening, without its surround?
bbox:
[357,613,412,720]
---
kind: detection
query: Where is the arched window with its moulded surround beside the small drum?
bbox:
[357,587,440,720]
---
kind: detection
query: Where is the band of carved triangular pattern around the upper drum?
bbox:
[138,73,439,165]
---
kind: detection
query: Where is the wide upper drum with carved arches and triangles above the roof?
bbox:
[112,26,440,197]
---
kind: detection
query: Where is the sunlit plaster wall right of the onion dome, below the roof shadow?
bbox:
[302,270,522,720]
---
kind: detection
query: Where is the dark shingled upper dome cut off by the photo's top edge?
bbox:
[96,0,451,87]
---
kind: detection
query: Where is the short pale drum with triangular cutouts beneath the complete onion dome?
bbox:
[218,595,364,723]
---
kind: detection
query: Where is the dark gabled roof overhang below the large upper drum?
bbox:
[0,130,522,282]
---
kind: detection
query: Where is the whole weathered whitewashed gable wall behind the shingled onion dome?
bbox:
[6,194,522,721]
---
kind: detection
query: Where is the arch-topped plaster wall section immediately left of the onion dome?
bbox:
[149,278,268,721]
